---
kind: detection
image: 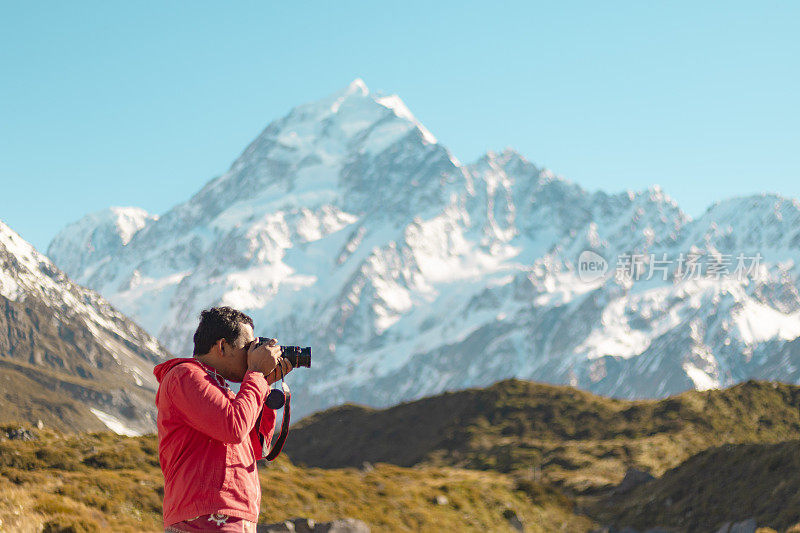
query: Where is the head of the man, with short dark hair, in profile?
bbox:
[194,307,255,381]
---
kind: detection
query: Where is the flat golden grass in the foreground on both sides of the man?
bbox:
[0,425,593,532]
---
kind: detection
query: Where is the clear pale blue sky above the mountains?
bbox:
[0,1,800,250]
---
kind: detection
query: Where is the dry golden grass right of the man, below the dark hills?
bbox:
[262,454,594,531]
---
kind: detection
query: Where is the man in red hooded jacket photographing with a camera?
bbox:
[153,307,292,532]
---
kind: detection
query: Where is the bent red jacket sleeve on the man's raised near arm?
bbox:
[167,365,269,444]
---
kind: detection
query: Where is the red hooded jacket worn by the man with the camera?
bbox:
[153,358,275,527]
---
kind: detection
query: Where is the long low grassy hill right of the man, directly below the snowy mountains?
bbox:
[285,380,800,493]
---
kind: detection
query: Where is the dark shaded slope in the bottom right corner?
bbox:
[592,440,800,531]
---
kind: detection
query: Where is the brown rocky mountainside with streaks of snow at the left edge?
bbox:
[0,222,168,434]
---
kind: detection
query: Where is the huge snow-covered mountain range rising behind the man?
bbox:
[49,80,800,418]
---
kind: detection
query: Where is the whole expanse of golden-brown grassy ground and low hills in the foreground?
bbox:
[0,380,800,532]
